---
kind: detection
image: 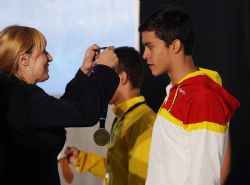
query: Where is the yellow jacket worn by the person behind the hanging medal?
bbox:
[74,96,156,185]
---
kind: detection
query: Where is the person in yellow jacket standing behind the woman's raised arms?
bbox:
[65,47,156,185]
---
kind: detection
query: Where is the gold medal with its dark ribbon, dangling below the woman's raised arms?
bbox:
[93,106,110,146]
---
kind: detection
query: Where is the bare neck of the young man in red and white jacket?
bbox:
[168,55,197,85]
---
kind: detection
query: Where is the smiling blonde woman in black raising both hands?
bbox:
[0,25,119,185]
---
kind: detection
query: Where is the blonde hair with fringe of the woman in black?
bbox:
[0,25,46,74]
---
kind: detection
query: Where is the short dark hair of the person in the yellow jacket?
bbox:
[115,47,144,88]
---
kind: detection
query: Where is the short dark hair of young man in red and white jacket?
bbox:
[139,5,196,55]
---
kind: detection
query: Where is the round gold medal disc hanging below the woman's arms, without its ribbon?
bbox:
[93,128,110,146]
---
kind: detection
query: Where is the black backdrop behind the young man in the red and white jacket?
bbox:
[140,0,250,185]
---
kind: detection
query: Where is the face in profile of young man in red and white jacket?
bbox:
[142,31,170,76]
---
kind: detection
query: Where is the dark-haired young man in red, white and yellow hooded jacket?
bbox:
[139,6,239,185]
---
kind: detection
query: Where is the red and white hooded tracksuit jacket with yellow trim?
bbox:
[146,68,239,185]
